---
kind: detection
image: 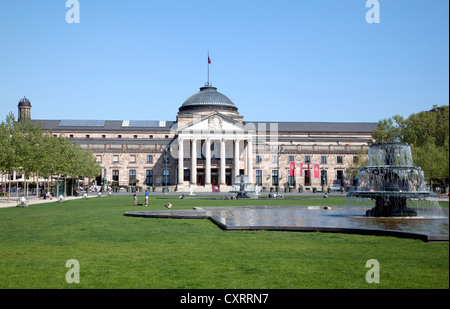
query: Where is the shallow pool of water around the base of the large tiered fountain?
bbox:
[201,206,449,237]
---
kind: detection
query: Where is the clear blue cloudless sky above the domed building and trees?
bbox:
[0,0,449,122]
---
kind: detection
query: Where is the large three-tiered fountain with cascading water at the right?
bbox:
[347,143,435,217]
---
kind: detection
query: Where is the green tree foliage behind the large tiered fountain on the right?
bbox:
[373,105,449,188]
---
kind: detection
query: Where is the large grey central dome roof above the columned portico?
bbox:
[179,85,238,112]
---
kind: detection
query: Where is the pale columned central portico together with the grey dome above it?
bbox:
[176,84,255,192]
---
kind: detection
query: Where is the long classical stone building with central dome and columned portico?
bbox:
[18,84,376,192]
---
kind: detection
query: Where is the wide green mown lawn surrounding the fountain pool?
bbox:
[0,196,449,289]
